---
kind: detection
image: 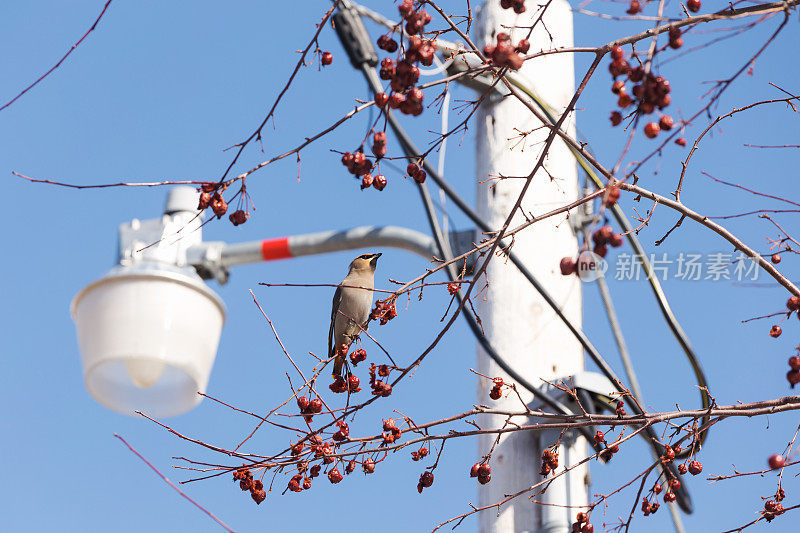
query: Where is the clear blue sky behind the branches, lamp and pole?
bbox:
[0,1,800,532]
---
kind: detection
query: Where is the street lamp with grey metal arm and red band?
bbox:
[71,186,456,417]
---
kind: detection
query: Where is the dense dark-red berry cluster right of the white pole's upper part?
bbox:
[608,47,686,139]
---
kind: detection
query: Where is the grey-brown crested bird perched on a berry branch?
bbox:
[328,254,381,378]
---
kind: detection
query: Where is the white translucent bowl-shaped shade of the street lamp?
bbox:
[72,263,225,417]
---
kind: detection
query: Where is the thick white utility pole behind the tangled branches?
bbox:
[476,0,588,533]
